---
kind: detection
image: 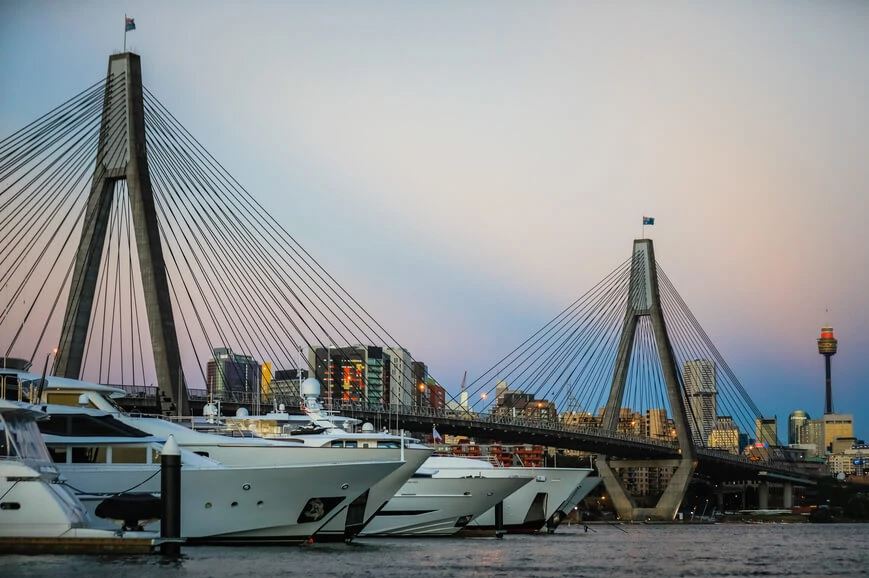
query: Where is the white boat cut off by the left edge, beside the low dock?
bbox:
[0,399,156,541]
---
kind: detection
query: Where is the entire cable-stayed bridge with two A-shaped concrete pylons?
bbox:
[0,53,811,519]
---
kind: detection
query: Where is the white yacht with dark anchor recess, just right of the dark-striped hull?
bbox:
[425,456,592,534]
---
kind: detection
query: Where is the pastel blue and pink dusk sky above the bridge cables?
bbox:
[0,0,869,438]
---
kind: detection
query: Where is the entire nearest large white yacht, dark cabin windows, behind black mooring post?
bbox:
[34,405,401,543]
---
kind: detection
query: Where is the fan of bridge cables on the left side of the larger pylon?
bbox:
[0,77,133,363]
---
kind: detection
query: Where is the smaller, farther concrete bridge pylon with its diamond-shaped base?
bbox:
[597,239,697,520]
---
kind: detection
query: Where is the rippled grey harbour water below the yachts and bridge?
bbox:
[0,524,869,578]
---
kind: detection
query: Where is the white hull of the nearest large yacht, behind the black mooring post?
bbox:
[58,462,401,543]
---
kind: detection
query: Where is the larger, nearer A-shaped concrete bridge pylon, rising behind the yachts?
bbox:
[54,52,188,414]
